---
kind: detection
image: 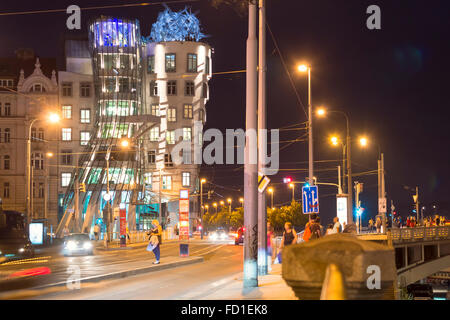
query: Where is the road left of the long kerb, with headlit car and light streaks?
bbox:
[0,240,242,299]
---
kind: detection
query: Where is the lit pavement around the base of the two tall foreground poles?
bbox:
[181,264,298,300]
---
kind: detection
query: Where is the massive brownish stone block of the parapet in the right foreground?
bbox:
[282,234,397,300]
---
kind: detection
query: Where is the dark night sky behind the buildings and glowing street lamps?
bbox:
[0,0,450,222]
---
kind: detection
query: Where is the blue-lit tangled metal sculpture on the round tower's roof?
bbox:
[146,6,206,42]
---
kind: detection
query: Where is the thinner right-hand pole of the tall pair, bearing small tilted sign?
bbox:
[258,0,267,275]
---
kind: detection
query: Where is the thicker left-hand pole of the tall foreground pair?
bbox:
[243,1,258,288]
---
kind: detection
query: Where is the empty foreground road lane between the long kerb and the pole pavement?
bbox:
[21,243,243,300]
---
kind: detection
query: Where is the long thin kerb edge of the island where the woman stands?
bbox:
[33,257,204,290]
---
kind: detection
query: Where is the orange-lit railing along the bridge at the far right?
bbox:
[389,226,450,242]
